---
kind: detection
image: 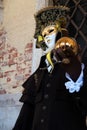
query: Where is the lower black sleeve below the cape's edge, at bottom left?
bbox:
[13,103,34,130]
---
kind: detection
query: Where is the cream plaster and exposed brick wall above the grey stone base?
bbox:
[0,0,35,93]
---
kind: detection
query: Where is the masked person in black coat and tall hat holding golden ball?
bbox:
[13,6,87,130]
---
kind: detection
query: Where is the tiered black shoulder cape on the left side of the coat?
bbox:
[20,56,45,104]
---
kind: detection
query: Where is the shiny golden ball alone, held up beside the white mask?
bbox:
[55,37,79,64]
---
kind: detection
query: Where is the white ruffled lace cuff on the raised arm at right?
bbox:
[65,63,84,93]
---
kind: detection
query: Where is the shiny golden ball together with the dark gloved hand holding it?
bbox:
[52,37,79,64]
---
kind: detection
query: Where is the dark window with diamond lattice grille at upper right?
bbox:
[49,0,87,47]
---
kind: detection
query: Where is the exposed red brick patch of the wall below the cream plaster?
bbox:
[0,28,32,94]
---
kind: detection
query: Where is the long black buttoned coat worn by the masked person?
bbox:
[13,48,87,130]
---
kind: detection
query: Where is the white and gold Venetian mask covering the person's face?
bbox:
[42,25,58,53]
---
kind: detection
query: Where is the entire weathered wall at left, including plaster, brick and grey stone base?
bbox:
[0,0,35,130]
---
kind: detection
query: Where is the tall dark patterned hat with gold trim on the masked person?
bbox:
[34,6,69,39]
